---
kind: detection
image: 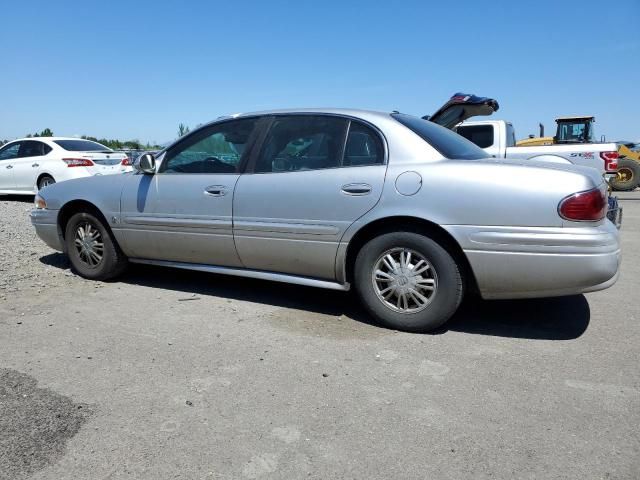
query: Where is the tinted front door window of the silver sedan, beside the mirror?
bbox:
[160,118,258,173]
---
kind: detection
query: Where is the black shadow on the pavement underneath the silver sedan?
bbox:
[40,253,590,340]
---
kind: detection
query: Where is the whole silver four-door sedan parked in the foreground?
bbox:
[31,109,620,331]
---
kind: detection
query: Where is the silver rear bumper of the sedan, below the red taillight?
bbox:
[444,220,621,299]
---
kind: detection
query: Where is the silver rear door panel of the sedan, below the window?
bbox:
[233,165,387,280]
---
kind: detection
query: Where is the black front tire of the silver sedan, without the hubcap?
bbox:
[65,212,128,280]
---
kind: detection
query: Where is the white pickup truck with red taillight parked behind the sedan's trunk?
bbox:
[454,120,618,176]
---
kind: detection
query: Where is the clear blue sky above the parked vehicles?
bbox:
[0,0,640,142]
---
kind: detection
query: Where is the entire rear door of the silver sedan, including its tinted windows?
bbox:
[233,115,386,280]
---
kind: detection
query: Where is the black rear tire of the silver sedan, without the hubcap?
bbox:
[354,232,464,332]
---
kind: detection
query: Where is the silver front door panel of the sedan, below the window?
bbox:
[117,173,242,267]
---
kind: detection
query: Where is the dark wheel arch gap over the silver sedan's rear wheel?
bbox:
[343,215,479,293]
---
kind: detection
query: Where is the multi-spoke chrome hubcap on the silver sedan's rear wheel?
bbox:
[371,248,438,313]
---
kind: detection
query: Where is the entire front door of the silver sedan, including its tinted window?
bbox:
[121,118,259,267]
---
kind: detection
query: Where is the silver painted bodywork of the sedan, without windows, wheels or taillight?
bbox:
[32,109,620,298]
